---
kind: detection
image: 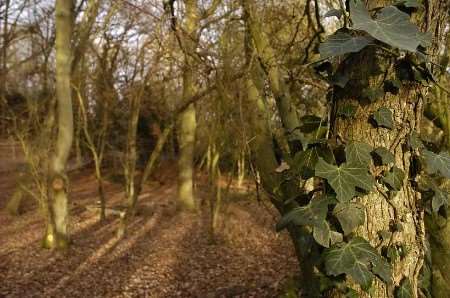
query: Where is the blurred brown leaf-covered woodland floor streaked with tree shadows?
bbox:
[0,144,297,297]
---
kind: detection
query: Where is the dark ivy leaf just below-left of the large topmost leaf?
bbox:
[319,32,371,59]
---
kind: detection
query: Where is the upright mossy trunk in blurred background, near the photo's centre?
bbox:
[178,0,199,211]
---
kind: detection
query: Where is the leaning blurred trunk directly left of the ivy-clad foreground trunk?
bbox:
[241,18,319,297]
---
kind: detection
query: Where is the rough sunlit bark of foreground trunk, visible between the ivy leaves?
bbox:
[330,1,446,297]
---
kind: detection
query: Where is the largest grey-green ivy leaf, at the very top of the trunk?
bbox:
[350,0,421,52]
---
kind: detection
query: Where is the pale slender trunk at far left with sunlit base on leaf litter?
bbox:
[44,0,74,249]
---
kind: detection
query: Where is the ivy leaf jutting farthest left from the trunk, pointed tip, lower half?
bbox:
[276,197,332,231]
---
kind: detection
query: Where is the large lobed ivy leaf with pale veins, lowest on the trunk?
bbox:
[324,237,390,288]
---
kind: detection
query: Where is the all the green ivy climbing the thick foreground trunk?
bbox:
[277,0,450,297]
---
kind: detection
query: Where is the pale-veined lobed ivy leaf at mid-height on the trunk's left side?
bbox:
[316,158,374,202]
